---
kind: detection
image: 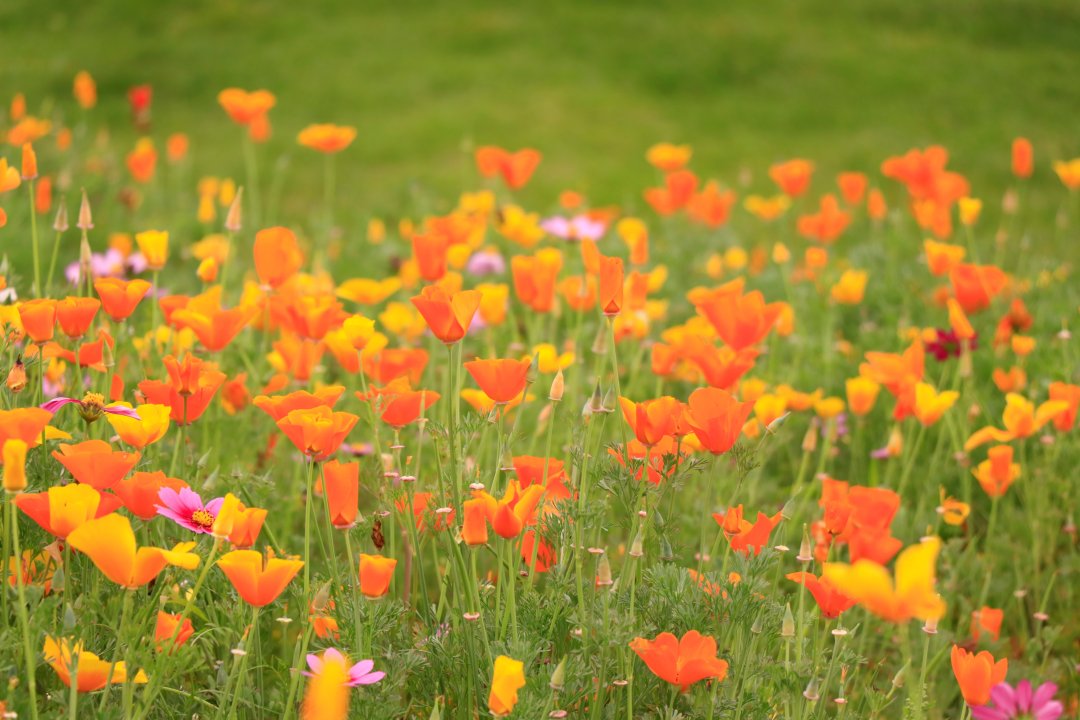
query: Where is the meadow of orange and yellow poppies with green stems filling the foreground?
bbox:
[0,7,1080,720]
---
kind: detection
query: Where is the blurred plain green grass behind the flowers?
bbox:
[6,0,1080,234]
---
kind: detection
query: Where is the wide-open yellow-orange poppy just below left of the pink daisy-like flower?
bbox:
[67,513,199,589]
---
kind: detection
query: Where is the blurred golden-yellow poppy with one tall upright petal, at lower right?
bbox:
[822,538,945,623]
